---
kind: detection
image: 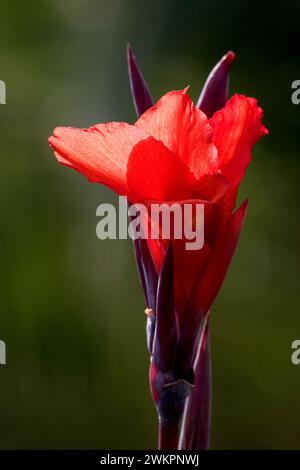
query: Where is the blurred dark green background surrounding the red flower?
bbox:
[0,0,300,449]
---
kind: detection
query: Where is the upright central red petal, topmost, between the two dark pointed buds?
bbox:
[136,90,218,178]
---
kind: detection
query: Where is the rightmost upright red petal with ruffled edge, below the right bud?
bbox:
[209,95,268,192]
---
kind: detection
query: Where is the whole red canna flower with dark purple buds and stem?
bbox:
[49,50,268,449]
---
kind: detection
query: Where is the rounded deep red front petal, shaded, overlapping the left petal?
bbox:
[127,137,195,202]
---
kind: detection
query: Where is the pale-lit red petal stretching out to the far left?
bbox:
[49,122,147,194]
